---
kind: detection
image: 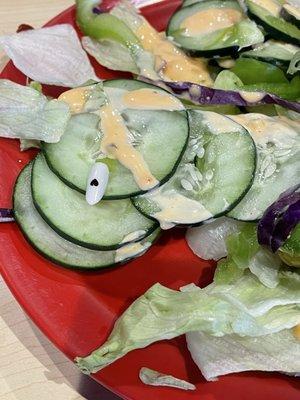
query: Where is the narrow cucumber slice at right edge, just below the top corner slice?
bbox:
[241,40,300,68]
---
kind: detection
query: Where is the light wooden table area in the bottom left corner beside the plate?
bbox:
[0,278,118,400]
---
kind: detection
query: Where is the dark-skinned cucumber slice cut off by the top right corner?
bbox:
[246,0,300,45]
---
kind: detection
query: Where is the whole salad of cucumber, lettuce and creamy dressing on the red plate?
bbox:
[0,0,300,390]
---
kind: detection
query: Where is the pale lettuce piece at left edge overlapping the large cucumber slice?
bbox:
[0,79,70,143]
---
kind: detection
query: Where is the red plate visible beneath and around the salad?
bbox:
[0,1,299,400]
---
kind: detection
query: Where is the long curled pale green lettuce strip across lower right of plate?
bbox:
[75,271,300,374]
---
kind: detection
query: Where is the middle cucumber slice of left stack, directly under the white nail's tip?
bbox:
[32,154,157,250]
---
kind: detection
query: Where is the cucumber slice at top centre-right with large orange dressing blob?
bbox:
[167,0,264,57]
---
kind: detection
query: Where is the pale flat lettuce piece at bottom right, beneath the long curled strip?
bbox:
[186,329,300,381]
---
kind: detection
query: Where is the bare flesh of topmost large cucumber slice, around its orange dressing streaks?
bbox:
[43,79,189,199]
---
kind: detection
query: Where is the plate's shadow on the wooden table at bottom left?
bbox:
[0,288,120,400]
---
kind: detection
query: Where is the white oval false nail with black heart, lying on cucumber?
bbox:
[85,162,109,206]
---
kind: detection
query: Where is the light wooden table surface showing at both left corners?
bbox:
[0,0,119,400]
